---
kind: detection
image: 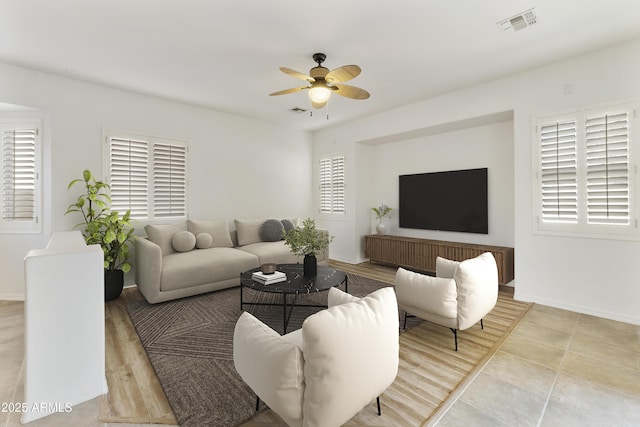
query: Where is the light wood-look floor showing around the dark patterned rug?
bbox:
[99,261,527,427]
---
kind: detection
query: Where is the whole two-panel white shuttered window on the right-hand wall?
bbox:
[536,104,639,238]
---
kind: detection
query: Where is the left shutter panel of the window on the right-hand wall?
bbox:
[539,120,578,223]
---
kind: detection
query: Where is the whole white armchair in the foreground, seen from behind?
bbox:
[233,287,399,427]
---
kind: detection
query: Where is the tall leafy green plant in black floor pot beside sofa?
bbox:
[65,169,135,301]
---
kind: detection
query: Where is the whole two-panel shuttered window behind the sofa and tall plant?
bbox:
[106,132,187,220]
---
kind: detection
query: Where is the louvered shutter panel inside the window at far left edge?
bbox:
[2,128,39,222]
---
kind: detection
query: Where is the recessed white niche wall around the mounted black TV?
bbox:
[367,121,514,247]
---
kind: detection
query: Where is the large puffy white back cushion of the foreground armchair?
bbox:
[302,287,399,427]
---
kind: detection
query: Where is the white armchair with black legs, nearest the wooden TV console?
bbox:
[396,252,498,351]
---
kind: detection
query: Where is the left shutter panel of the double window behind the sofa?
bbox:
[109,138,149,219]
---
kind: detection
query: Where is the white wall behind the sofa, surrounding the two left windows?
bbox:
[0,63,312,299]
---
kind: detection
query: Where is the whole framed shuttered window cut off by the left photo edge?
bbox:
[0,122,42,233]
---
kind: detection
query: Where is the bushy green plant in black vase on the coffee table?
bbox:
[283,218,333,277]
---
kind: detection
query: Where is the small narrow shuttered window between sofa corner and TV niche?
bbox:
[320,155,346,214]
